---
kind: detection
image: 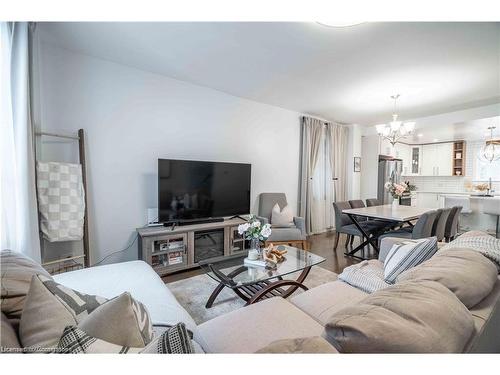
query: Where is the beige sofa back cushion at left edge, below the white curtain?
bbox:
[0,250,50,326]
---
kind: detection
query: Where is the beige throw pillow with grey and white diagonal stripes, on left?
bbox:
[19,275,107,348]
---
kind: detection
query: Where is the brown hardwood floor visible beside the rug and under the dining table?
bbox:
[163,231,374,283]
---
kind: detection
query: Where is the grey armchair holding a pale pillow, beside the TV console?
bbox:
[257,193,308,250]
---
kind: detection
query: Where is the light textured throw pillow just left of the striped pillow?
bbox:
[339,259,390,293]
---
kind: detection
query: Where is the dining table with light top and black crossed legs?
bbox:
[342,204,433,260]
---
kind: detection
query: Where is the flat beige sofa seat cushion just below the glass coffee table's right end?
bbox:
[290,280,368,326]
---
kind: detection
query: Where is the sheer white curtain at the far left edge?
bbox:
[0,22,41,262]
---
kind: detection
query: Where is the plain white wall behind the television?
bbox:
[40,44,300,262]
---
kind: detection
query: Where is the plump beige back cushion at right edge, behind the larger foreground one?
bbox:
[398,248,497,308]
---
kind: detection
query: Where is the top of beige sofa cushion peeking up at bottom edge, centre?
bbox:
[256,336,338,354]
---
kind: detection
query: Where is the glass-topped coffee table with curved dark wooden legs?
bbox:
[200,246,325,308]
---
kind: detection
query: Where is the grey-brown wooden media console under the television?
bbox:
[137,218,250,276]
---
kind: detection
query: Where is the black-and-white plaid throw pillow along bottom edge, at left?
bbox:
[55,323,194,354]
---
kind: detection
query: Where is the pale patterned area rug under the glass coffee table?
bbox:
[167,266,337,324]
